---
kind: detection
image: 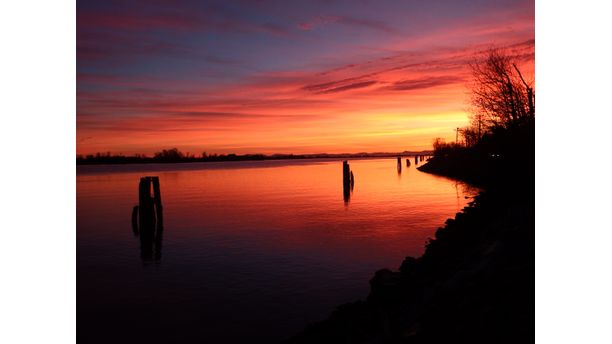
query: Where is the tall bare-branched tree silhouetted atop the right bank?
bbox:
[470,49,535,132]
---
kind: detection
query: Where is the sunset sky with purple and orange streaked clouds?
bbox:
[77,0,534,155]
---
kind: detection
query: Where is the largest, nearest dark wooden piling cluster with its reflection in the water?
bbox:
[132,177,163,261]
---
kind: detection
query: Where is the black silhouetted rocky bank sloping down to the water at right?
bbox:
[286,158,535,343]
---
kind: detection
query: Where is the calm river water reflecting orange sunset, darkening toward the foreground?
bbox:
[77,159,477,343]
